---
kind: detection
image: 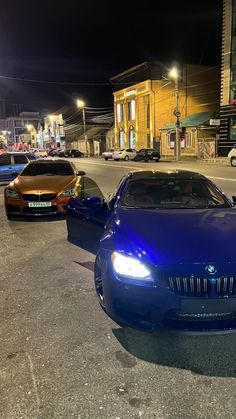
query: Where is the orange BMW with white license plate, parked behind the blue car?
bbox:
[4,159,85,218]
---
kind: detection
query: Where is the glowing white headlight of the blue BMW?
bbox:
[111,252,151,279]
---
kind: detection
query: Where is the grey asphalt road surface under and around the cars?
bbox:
[0,159,236,419]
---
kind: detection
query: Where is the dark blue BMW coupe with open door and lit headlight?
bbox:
[67,170,236,333]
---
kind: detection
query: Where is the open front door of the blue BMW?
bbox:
[66,176,109,254]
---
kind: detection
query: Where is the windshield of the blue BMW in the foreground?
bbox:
[121,178,230,209]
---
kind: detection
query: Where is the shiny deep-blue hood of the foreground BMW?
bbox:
[113,208,236,265]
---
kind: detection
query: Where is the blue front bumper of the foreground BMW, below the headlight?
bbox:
[102,267,236,333]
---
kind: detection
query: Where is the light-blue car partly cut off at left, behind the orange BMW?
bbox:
[0,151,37,183]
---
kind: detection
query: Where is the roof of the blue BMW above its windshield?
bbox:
[128,169,206,180]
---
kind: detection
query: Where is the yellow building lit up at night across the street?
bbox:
[113,64,220,156]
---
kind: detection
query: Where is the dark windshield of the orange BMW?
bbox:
[21,162,74,176]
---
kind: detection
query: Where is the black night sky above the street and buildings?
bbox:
[0,0,223,112]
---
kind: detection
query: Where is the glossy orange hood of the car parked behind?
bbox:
[10,175,76,193]
